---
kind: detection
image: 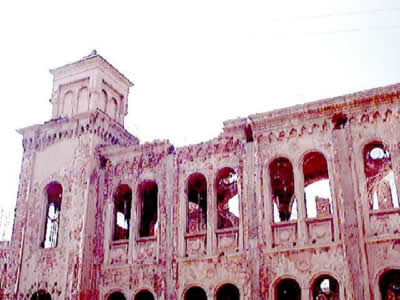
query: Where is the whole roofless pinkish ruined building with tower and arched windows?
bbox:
[0,54,400,300]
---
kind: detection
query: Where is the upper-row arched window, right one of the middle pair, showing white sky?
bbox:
[216,168,240,229]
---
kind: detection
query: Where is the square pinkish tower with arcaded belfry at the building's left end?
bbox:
[5,51,139,299]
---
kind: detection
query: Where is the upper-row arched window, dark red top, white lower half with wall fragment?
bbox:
[303,152,332,218]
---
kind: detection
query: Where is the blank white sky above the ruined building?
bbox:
[0,0,400,216]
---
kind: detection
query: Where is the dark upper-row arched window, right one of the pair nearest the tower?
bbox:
[139,180,158,237]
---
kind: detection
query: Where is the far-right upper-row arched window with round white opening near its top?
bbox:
[363,141,399,209]
